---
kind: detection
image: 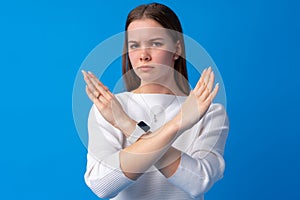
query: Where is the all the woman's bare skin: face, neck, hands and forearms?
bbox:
[82,19,219,180]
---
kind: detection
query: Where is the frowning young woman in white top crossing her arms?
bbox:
[83,3,229,200]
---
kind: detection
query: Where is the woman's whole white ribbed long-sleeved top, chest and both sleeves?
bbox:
[84,92,229,200]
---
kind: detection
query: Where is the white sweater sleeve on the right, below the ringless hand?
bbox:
[168,104,229,198]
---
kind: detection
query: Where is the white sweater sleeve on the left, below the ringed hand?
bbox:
[84,105,134,198]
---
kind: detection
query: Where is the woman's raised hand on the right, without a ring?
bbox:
[174,67,219,130]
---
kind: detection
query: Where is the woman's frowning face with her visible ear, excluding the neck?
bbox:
[127,19,180,83]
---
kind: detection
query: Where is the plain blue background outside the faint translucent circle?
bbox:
[0,0,300,200]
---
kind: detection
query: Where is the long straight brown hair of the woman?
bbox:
[122,3,190,95]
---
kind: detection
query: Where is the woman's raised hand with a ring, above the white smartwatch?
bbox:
[82,70,134,135]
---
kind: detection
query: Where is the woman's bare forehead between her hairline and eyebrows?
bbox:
[127,19,169,41]
